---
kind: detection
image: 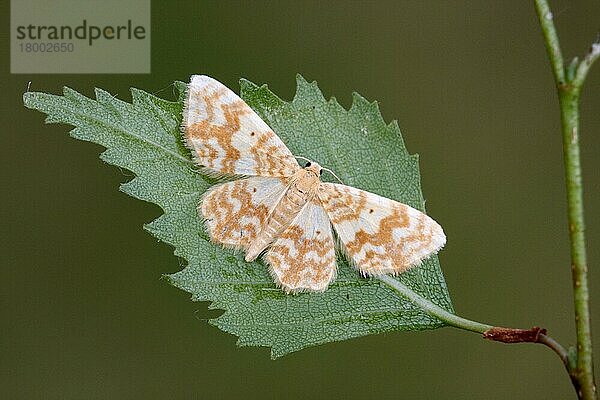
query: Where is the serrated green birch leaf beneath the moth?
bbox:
[24,76,452,358]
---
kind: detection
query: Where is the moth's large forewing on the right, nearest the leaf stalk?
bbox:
[319,183,446,275]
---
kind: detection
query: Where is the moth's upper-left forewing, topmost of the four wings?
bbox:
[182,75,300,177]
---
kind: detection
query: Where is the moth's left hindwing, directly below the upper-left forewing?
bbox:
[200,177,286,250]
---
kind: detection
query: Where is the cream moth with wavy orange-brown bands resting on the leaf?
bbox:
[182,75,446,293]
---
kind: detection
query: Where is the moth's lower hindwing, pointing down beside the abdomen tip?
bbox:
[265,199,336,292]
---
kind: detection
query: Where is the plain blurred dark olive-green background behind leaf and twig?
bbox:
[0,0,600,399]
